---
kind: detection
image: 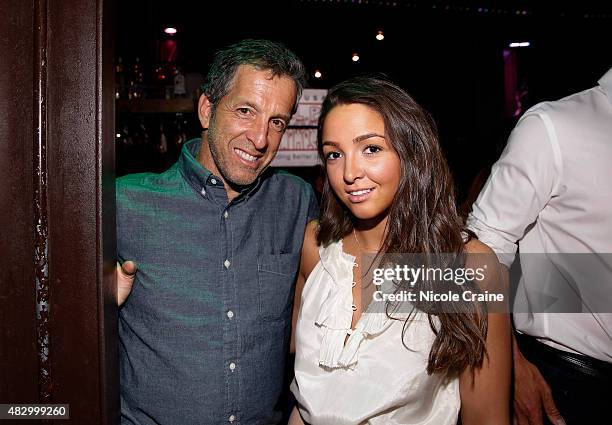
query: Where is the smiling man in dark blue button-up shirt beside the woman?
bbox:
[117,40,317,425]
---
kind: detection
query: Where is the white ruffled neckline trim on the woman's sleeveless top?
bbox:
[315,240,392,369]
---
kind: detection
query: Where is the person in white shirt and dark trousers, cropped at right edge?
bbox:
[468,69,612,425]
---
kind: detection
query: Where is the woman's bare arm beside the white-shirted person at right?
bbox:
[459,240,512,425]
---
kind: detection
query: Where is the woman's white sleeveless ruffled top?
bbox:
[291,241,461,425]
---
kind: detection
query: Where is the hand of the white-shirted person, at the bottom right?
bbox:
[513,340,565,425]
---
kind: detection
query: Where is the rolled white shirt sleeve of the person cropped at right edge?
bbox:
[467,113,561,267]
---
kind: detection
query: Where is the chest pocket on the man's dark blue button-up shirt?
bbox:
[257,253,300,321]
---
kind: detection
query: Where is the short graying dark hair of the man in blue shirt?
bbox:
[202,39,305,114]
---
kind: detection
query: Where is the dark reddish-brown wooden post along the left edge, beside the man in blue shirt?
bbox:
[0,0,119,424]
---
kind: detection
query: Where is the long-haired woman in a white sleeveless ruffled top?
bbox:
[289,77,510,425]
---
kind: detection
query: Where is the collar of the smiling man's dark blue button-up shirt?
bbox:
[178,139,267,202]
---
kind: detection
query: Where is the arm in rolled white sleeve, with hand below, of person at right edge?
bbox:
[467,114,563,425]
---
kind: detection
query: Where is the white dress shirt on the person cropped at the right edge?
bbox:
[468,69,612,362]
